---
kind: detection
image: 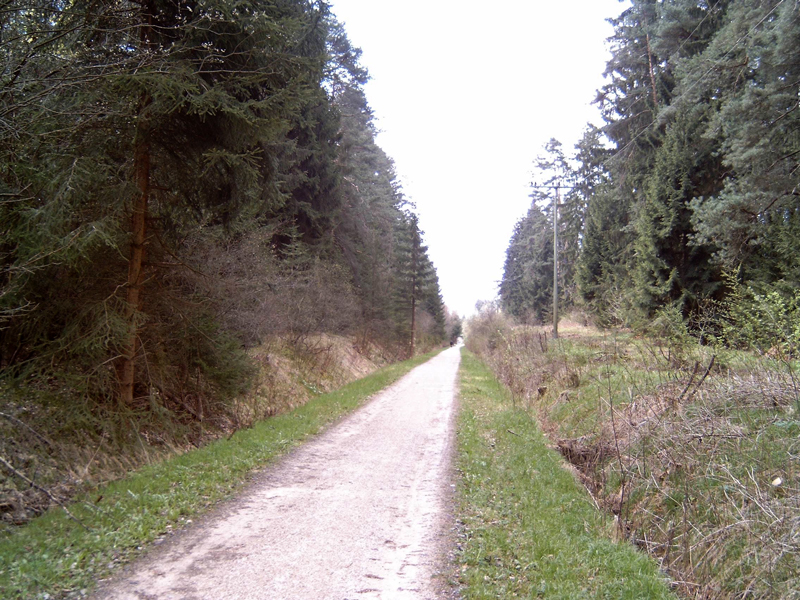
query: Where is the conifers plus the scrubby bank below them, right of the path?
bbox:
[488,0,800,599]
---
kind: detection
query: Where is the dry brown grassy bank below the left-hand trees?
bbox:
[0,335,386,525]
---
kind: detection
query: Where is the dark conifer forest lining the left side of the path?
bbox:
[0,0,457,520]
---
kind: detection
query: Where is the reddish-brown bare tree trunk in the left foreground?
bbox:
[118,113,150,406]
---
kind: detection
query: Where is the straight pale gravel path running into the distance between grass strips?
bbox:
[95,348,460,600]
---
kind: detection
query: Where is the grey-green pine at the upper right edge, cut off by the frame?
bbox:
[686,0,800,286]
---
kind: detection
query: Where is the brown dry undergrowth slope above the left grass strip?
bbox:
[0,335,385,526]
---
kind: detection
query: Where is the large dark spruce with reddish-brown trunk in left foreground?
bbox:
[0,0,332,404]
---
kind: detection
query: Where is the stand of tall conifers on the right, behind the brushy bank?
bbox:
[500,0,800,351]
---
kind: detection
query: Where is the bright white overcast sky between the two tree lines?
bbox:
[332,0,628,316]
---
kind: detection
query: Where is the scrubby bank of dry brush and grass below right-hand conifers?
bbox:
[468,315,800,599]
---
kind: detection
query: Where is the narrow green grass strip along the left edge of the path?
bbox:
[0,353,434,600]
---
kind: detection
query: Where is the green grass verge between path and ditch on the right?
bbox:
[458,351,674,599]
